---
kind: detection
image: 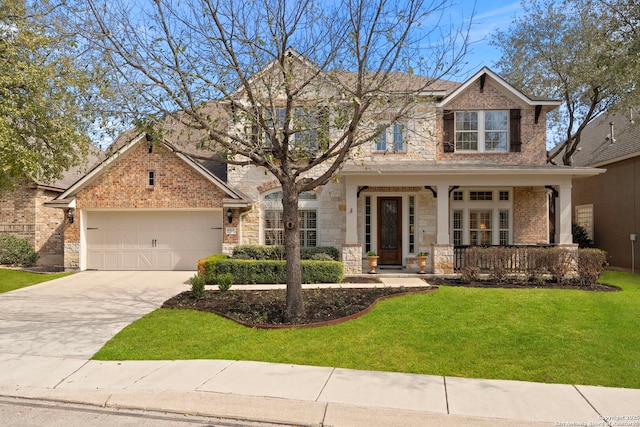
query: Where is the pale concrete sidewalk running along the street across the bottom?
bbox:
[0,354,640,426]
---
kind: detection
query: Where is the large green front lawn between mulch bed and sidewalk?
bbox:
[94,271,640,388]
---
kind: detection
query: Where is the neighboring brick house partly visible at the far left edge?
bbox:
[0,155,99,268]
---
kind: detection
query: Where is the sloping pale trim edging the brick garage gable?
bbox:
[47,131,251,207]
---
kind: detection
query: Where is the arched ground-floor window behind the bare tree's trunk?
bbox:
[262,190,318,246]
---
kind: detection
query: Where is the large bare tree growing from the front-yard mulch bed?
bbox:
[82,0,469,318]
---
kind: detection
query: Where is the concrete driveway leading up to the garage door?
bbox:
[0,271,194,360]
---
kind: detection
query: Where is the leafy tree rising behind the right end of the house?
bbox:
[493,0,639,165]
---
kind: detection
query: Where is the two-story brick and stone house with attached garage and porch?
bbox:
[50,62,600,274]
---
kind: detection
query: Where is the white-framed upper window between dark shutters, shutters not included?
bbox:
[455,111,509,152]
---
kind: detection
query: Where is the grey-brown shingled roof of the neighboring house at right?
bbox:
[573,112,640,166]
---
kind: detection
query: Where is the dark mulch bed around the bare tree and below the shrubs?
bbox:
[162,276,620,329]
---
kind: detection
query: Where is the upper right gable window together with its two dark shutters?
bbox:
[442,109,522,153]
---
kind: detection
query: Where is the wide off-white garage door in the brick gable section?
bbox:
[86,211,222,270]
